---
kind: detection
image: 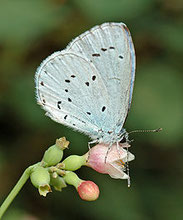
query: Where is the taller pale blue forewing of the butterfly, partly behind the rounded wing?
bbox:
[66,23,135,131]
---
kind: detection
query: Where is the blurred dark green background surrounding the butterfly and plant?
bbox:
[0,0,183,220]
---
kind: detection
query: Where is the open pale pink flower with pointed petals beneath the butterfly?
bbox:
[86,143,135,179]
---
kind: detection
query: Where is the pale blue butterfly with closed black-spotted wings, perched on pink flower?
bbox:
[35,23,135,145]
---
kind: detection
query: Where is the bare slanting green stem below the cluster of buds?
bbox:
[0,164,37,219]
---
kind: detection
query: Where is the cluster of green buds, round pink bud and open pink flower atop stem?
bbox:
[30,137,134,201]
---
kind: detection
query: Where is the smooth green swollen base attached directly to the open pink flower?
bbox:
[62,155,87,171]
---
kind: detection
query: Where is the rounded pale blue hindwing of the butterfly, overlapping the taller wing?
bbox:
[36,51,108,137]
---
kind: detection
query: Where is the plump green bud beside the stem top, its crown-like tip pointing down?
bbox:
[30,166,51,196]
